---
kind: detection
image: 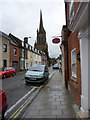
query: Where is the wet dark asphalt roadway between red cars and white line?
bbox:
[2,68,54,118]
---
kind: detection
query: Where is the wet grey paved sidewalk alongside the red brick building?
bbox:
[22,71,79,118]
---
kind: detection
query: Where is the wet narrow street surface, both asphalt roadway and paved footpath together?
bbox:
[3,68,79,119]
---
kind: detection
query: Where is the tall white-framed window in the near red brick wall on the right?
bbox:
[71,48,77,78]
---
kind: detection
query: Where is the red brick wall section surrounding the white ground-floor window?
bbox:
[68,33,81,106]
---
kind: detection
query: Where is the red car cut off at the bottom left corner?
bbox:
[0,89,7,120]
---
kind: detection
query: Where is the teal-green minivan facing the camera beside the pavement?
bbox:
[25,65,49,83]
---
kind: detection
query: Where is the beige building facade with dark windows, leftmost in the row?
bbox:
[0,31,10,67]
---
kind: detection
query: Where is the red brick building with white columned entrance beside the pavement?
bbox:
[61,0,90,117]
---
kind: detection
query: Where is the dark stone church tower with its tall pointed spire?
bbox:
[34,10,48,52]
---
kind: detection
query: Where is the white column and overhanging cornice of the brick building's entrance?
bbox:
[69,0,90,118]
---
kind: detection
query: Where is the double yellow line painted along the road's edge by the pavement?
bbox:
[8,85,43,120]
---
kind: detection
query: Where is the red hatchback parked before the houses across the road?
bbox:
[0,67,16,78]
